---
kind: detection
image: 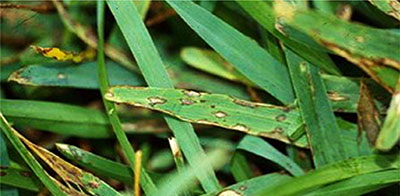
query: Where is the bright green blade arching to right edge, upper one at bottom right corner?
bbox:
[254,155,400,196]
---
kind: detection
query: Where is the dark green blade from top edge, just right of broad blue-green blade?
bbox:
[237,0,340,75]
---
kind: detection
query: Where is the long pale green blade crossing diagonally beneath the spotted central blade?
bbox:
[107,1,220,192]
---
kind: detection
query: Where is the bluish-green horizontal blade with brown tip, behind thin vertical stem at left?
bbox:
[8,61,144,89]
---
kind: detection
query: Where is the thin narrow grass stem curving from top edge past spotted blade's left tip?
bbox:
[97,0,157,195]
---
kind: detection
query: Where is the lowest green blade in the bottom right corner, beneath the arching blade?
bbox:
[307,169,400,196]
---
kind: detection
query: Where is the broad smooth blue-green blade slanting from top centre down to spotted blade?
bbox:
[167,1,294,104]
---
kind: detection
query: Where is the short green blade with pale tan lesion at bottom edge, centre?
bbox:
[202,173,291,196]
